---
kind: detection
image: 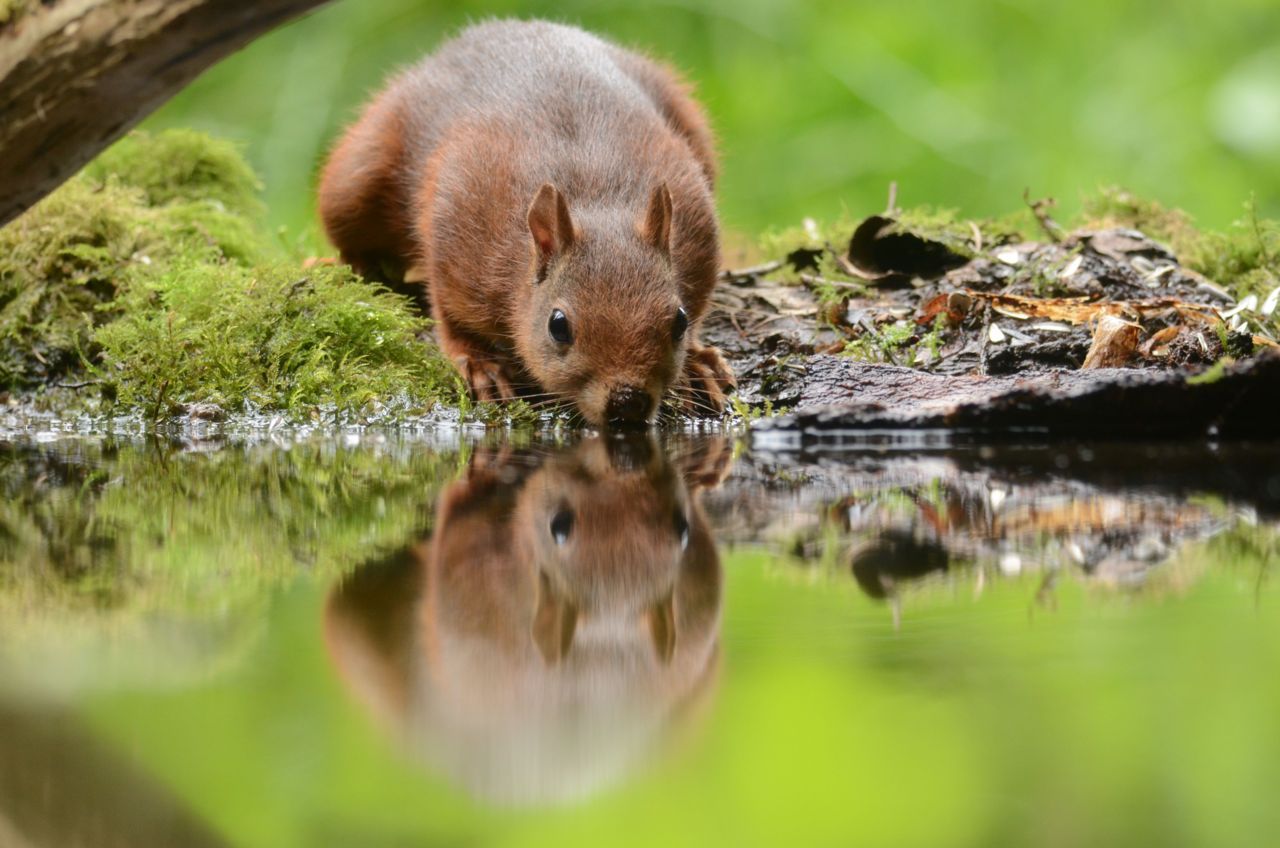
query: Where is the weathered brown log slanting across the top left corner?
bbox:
[0,0,324,224]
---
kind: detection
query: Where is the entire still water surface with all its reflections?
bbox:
[0,433,1280,848]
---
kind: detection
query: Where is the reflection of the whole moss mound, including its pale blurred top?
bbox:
[0,438,457,694]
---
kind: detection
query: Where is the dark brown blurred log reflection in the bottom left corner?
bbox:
[0,703,224,848]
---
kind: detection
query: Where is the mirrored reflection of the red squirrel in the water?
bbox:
[325,437,730,803]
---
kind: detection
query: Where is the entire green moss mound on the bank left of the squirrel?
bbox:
[0,131,461,416]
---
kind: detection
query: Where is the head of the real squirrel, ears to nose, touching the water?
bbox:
[516,183,694,427]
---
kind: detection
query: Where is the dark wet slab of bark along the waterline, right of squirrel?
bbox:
[755,354,1280,444]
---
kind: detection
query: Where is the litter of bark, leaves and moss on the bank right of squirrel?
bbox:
[705,190,1280,433]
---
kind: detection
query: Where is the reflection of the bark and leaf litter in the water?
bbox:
[732,444,1280,621]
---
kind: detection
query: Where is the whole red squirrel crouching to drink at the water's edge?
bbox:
[319,20,733,427]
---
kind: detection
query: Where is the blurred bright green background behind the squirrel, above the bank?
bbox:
[148,0,1280,249]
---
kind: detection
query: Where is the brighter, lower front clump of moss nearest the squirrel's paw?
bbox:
[95,261,460,415]
